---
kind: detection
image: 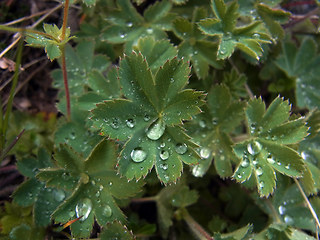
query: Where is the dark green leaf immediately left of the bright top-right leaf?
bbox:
[173,8,222,78]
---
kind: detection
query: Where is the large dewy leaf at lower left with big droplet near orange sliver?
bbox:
[38,140,142,237]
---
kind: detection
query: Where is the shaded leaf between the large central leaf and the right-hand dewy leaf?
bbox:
[187,85,244,177]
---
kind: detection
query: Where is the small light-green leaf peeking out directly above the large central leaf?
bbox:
[134,37,177,73]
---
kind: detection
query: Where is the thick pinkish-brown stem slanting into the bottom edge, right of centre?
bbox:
[177,208,214,240]
